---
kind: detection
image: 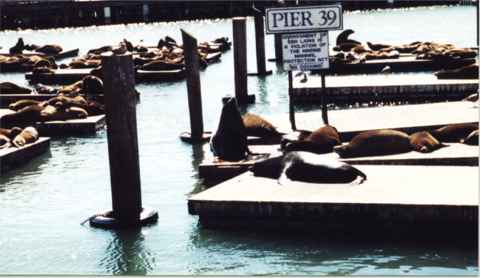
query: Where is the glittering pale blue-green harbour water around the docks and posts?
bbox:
[0,4,478,275]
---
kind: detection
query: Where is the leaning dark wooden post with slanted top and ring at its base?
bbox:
[180,30,211,142]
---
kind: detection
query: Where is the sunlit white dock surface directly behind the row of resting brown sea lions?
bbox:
[276,101,479,142]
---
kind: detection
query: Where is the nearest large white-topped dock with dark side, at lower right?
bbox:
[188,165,479,238]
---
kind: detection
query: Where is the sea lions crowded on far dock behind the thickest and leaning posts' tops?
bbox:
[67,36,231,71]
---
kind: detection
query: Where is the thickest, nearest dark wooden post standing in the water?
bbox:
[102,55,142,226]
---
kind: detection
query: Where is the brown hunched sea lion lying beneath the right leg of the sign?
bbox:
[283,125,342,154]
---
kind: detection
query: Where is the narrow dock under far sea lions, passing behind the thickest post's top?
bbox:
[25,68,185,85]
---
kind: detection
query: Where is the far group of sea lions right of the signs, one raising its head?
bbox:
[332,29,478,79]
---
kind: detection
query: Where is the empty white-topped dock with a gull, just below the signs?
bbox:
[290,73,479,104]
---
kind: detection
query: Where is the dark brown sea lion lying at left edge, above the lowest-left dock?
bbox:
[0,105,43,128]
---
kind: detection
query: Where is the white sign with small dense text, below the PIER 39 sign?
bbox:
[282,32,329,70]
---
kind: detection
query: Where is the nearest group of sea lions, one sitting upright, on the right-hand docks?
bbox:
[210,98,479,186]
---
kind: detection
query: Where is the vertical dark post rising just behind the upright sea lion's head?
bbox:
[232,17,254,104]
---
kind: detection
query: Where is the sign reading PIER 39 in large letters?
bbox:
[266,4,343,34]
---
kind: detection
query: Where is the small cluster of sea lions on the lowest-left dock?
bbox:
[0,126,39,149]
